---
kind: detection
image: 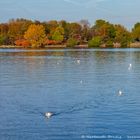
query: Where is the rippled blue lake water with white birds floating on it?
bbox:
[0,49,140,140]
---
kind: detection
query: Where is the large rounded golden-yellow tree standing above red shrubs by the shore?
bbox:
[24,24,46,48]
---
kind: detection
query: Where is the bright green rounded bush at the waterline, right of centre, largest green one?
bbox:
[88,37,102,48]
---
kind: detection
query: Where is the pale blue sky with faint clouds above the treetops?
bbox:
[0,0,140,29]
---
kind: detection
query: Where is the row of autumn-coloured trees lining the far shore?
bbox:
[0,18,140,48]
